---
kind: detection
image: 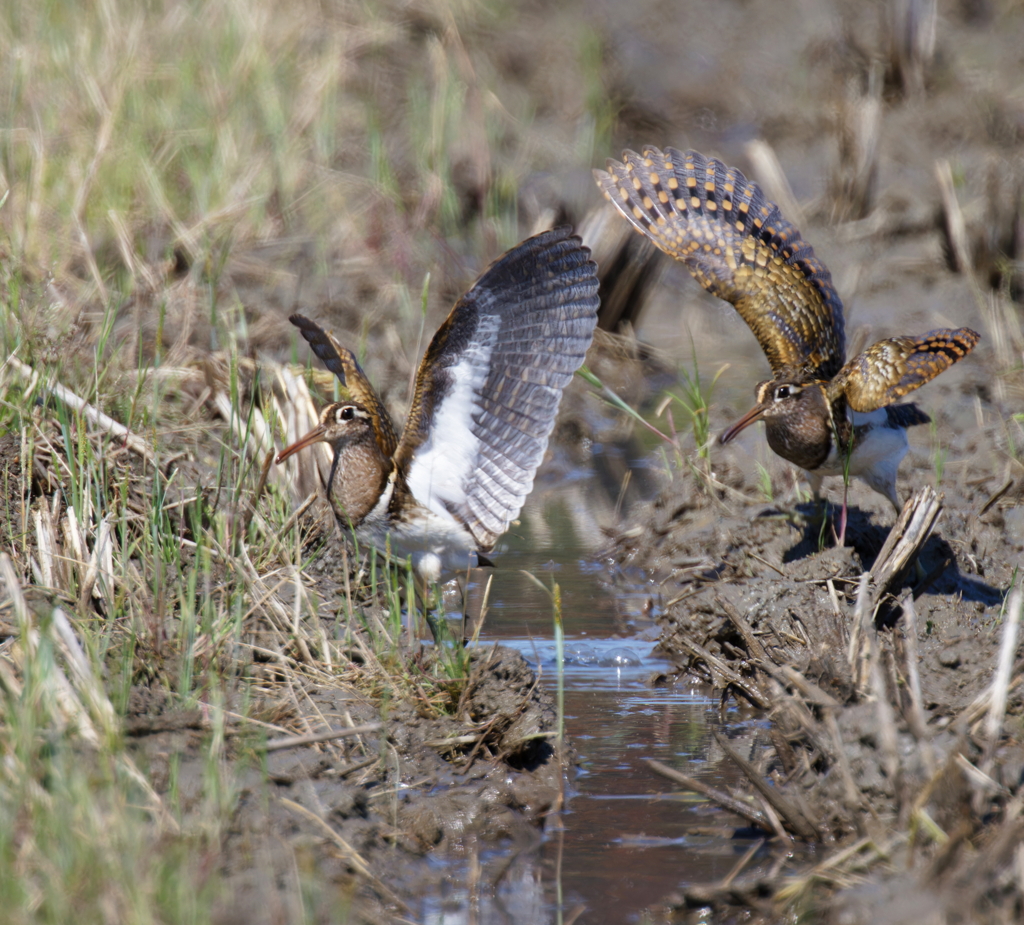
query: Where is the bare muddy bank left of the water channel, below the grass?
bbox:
[125,626,568,923]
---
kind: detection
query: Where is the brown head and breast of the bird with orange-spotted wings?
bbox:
[719,379,833,468]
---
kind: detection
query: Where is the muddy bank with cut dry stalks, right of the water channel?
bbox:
[614,374,1024,923]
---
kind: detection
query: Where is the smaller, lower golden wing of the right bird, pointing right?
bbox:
[827,328,981,411]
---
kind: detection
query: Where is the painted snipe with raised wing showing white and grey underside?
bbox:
[278,227,599,582]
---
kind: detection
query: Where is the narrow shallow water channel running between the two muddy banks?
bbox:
[417,492,766,925]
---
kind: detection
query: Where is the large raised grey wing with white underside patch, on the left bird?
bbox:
[395,227,599,551]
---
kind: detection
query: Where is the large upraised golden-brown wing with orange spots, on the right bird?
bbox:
[594,148,846,379]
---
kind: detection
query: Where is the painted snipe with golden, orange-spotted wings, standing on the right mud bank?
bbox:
[594,148,979,525]
